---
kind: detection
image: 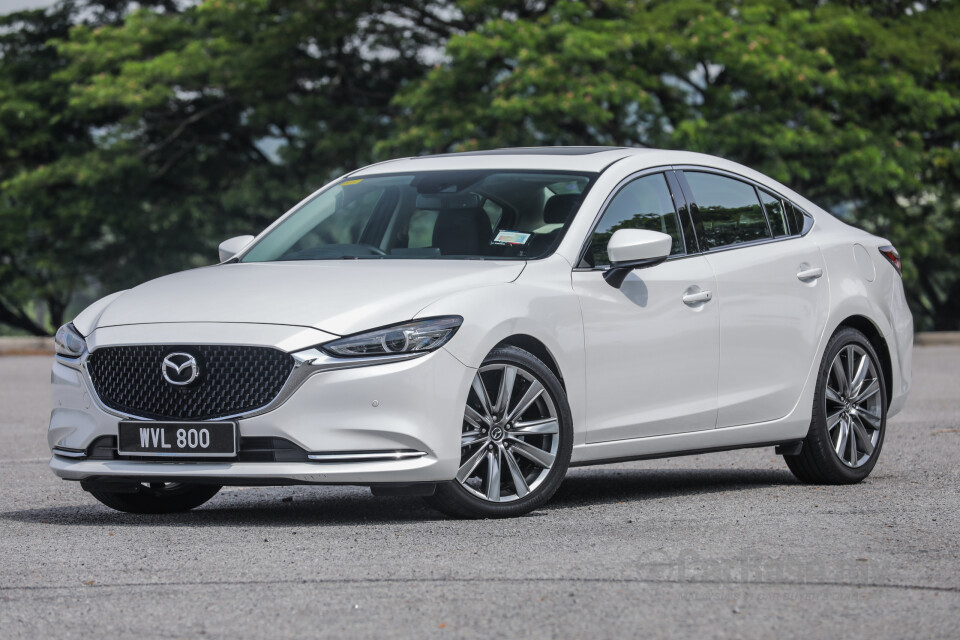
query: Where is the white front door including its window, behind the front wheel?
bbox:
[573,173,720,443]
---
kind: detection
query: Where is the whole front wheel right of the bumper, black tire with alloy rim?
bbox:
[425,347,573,518]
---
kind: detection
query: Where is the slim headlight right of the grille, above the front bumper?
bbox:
[320,316,463,358]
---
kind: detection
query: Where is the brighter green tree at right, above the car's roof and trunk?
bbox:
[379,0,960,329]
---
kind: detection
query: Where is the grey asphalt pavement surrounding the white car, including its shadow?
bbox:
[0,346,960,639]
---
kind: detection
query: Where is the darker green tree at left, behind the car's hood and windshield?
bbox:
[0,0,464,333]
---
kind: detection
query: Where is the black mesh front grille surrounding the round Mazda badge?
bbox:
[87,345,293,420]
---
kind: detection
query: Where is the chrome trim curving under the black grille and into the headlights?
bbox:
[54,343,424,424]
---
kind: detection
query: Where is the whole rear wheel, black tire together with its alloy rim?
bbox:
[783,327,887,484]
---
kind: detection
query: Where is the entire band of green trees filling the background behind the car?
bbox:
[0,0,960,333]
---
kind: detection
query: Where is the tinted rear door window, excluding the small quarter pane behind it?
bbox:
[684,171,770,249]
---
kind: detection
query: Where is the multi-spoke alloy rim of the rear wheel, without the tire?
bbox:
[824,344,883,468]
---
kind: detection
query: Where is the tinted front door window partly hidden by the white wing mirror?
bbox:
[587,173,684,266]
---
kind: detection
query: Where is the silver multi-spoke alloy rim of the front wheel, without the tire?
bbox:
[456,364,560,503]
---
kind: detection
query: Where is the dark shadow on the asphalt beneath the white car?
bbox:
[0,467,798,527]
